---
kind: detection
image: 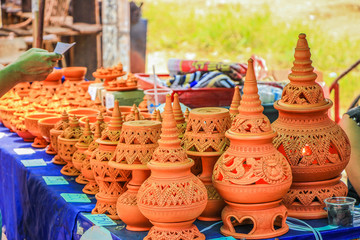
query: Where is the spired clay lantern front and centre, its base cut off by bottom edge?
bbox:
[137,95,207,240]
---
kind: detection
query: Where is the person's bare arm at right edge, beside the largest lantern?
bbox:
[340,112,360,196]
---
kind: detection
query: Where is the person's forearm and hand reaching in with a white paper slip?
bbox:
[0,48,62,97]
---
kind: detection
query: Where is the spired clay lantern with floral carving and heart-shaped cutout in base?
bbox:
[214,59,292,239]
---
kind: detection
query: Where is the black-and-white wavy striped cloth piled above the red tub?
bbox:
[166,71,235,89]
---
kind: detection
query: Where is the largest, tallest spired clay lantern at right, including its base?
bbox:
[272,34,350,219]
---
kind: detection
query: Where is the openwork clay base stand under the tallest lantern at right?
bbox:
[283,176,348,219]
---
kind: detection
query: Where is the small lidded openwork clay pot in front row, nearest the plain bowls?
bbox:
[58,116,83,176]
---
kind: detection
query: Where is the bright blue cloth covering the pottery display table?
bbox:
[0,125,360,240]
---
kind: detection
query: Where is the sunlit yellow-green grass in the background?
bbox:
[143,0,360,112]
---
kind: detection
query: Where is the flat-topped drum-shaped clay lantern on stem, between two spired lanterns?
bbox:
[183,107,231,221]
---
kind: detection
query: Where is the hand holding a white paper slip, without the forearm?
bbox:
[11,48,62,82]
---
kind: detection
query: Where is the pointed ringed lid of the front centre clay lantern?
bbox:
[153,94,189,163]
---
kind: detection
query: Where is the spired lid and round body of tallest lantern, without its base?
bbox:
[272,34,350,182]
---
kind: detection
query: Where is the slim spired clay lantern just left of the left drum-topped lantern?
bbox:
[90,101,131,219]
